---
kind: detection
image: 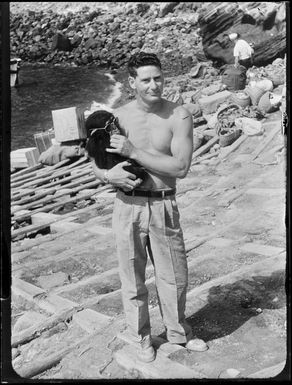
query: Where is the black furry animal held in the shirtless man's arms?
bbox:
[85,110,147,179]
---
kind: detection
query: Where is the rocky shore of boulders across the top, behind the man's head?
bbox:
[10,2,286,72]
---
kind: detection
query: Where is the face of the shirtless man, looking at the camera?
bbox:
[129,65,164,103]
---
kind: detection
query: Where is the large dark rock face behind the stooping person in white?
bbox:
[198,3,287,66]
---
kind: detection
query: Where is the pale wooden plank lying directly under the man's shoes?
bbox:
[114,345,205,379]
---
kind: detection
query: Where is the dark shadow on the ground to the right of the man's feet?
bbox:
[187,270,286,342]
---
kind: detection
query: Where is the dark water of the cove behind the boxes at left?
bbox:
[11,65,119,151]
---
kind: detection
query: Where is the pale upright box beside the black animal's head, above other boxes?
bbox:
[52,107,86,142]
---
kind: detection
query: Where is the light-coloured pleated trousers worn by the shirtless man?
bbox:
[113,191,191,343]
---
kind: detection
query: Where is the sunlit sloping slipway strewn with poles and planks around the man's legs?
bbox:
[11,111,289,379]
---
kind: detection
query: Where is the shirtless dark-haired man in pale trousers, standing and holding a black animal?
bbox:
[93,52,206,362]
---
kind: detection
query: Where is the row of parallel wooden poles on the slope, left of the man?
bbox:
[11,157,113,241]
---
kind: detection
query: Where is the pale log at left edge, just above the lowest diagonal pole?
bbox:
[11,306,83,348]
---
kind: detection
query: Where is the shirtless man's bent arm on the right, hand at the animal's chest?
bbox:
[107,107,193,178]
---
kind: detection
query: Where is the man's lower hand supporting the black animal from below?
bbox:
[108,159,142,191]
